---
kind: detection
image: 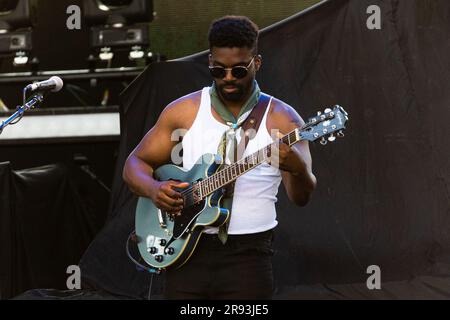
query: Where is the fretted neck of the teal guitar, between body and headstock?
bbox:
[198,129,302,198]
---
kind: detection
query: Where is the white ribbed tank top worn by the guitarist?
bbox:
[182,87,281,234]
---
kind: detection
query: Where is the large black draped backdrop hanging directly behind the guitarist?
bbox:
[81,0,450,298]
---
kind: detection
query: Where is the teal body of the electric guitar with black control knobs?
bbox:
[135,154,229,270]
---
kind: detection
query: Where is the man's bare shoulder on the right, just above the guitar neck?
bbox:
[267,98,305,133]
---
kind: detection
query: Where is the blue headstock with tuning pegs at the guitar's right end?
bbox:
[299,105,349,145]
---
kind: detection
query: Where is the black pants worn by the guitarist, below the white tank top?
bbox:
[164,230,273,300]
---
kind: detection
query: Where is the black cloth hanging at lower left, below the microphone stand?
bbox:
[0,162,98,299]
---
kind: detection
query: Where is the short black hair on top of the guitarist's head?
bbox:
[208,16,259,53]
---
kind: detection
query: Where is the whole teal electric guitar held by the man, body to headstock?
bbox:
[135,106,348,271]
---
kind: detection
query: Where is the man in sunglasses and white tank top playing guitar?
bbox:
[123,16,316,299]
